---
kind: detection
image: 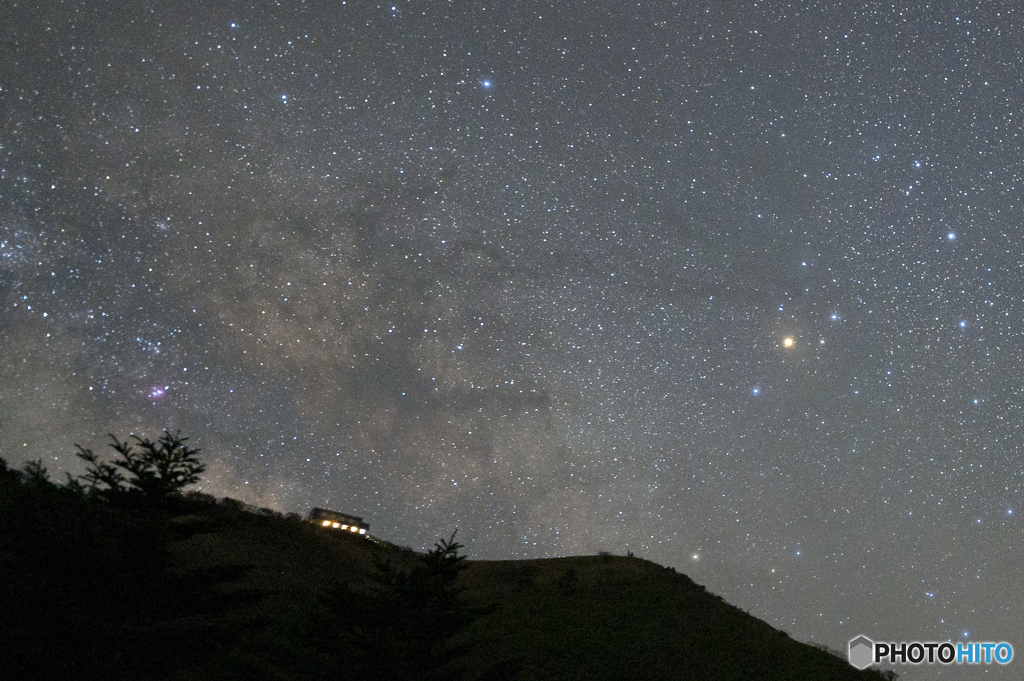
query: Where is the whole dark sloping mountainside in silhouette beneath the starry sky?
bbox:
[0,459,886,681]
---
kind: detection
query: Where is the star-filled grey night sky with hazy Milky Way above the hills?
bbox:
[0,0,1024,672]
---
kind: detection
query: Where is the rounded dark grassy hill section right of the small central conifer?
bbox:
[453,556,880,680]
